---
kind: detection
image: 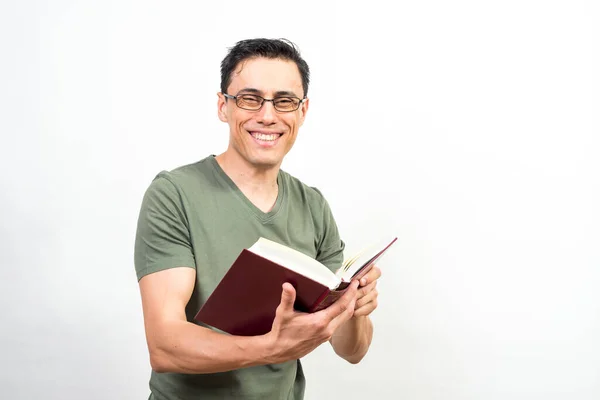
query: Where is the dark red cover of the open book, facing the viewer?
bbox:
[195,249,330,336]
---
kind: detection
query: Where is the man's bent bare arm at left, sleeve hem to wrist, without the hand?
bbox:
[139,267,267,373]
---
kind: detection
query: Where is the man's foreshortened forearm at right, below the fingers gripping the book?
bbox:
[330,316,373,364]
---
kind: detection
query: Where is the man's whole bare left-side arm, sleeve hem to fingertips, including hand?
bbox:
[139,267,357,374]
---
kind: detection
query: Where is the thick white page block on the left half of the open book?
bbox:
[248,238,340,289]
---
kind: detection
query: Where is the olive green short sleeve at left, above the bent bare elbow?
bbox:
[134,175,195,280]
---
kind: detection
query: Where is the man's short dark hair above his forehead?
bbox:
[221,38,310,96]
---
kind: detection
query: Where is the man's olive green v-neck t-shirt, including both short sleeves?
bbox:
[135,155,344,400]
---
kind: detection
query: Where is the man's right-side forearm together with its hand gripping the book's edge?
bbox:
[330,267,381,364]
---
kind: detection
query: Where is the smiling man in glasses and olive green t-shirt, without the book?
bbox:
[135,39,380,400]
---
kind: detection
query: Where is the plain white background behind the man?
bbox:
[0,0,600,400]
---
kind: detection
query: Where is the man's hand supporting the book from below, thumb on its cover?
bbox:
[265,281,358,364]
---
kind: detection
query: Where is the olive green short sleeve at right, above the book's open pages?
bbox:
[313,188,345,272]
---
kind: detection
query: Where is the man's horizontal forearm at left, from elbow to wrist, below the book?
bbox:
[148,321,270,374]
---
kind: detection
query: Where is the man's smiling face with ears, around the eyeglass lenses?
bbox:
[218,58,308,169]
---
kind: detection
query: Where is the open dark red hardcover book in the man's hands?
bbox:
[194,238,397,336]
